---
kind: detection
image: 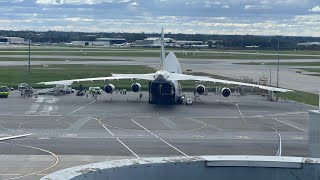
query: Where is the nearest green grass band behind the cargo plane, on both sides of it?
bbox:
[0,65,318,105]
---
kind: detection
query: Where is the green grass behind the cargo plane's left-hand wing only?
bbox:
[0,65,154,87]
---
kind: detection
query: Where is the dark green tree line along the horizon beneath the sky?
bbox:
[0,30,320,50]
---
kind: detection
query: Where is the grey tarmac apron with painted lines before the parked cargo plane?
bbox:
[0,91,316,179]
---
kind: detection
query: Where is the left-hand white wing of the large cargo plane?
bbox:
[37,73,154,85]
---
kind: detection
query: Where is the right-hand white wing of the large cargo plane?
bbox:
[168,74,293,92]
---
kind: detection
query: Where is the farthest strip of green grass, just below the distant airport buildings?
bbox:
[0,48,320,60]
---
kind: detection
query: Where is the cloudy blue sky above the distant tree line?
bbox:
[0,0,320,36]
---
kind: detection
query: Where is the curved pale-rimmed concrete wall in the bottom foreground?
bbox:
[42,156,320,180]
